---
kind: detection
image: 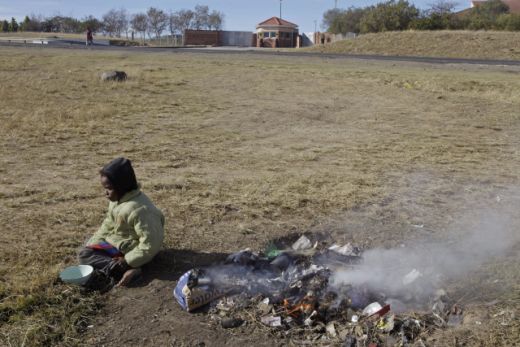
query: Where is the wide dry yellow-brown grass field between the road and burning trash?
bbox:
[0,48,520,346]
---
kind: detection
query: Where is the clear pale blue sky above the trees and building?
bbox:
[0,0,469,32]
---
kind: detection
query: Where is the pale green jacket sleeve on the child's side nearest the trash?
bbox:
[125,207,164,268]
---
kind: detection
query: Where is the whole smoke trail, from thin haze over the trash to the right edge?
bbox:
[191,196,520,312]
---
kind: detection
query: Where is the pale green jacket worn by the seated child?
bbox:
[88,189,164,268]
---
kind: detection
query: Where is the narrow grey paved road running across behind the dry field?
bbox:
[0,39,520,66]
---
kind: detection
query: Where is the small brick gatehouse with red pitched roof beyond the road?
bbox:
[256,17,301,48]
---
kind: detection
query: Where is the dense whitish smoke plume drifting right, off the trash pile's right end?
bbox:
[329,208,520,301]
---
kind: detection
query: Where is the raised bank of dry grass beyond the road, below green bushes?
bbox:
[310,30,520,60]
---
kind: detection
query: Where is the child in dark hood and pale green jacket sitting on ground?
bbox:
[78,158,164,286]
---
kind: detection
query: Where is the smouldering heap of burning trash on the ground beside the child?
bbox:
[174,236,462,346]
